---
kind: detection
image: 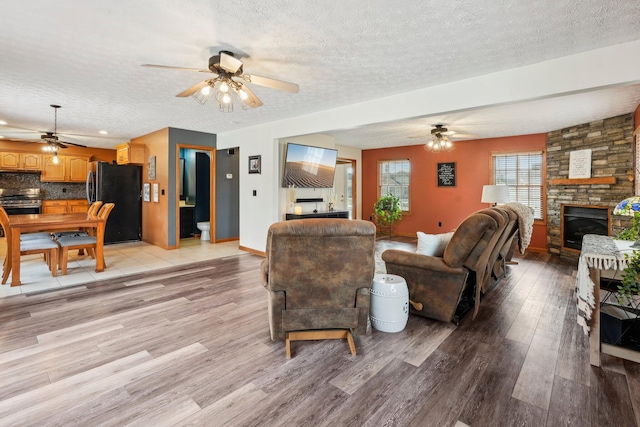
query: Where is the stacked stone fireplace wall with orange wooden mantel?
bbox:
[546,113,635,258]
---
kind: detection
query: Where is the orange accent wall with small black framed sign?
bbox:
[362,134,547,251]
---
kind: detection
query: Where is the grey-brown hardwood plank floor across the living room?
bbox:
[0,238,640,427]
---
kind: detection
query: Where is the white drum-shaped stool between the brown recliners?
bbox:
[370,274,409,332]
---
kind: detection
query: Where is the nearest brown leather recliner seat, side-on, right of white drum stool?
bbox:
[382,212,500,322]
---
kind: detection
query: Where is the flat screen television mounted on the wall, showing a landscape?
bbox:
[282,143,338,188]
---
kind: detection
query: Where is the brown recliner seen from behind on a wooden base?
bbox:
[261,219,376,355]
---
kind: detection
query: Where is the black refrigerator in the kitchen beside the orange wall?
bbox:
[87,162,142,244]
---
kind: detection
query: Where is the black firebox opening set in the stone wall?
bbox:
[561,205,611,251]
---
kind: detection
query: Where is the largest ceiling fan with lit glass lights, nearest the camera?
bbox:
[142,50,299,112]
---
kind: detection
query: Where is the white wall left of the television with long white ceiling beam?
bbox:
[217,41,640,251]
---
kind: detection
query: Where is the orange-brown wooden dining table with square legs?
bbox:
[9,212,106,286]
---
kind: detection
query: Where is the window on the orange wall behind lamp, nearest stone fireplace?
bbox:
[491,151,544,220]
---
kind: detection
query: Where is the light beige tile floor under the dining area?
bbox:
[0,237,247,298]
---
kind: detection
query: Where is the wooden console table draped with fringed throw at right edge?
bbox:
[576,234,640,366]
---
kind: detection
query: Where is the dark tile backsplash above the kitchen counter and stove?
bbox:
[0,172,87,200]
